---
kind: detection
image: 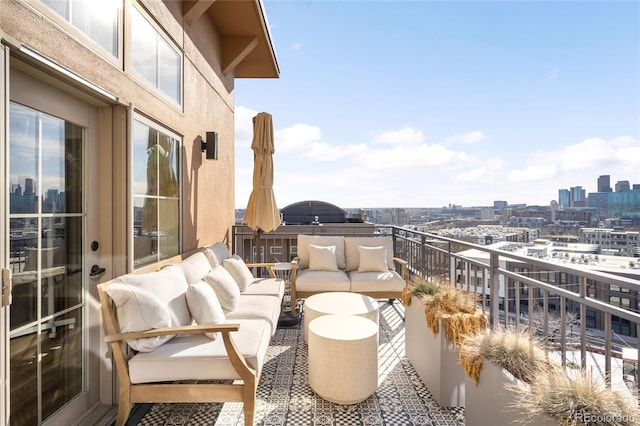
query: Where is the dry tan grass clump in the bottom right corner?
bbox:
[509,370,640,426]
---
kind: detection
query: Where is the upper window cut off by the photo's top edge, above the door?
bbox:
[42,0,120,58]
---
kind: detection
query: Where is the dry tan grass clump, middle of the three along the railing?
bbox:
[459,327,558,386]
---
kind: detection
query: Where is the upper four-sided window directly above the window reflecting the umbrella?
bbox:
[131,6,182,105]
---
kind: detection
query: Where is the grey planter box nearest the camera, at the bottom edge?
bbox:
[465,361,559,426]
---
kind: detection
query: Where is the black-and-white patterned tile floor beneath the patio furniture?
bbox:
[132,301,464,426]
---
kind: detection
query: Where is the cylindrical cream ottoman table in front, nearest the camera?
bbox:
[308,315,378,405]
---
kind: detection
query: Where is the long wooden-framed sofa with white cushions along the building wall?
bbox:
[98,243,284,425]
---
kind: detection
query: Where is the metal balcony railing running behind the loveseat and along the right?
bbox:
[232,224,640,389]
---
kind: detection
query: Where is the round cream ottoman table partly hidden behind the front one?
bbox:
[304,291,379,343]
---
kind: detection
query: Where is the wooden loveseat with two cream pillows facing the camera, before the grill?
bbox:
[291,234,407,306]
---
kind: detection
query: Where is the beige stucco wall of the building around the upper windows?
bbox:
[0,0,235,251]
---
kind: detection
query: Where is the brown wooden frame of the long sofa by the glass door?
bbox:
[97,252,275,426]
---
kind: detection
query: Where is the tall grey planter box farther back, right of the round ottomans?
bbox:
[404,297,464,406]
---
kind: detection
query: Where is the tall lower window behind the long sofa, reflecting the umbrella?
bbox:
[132,117,181,267]
